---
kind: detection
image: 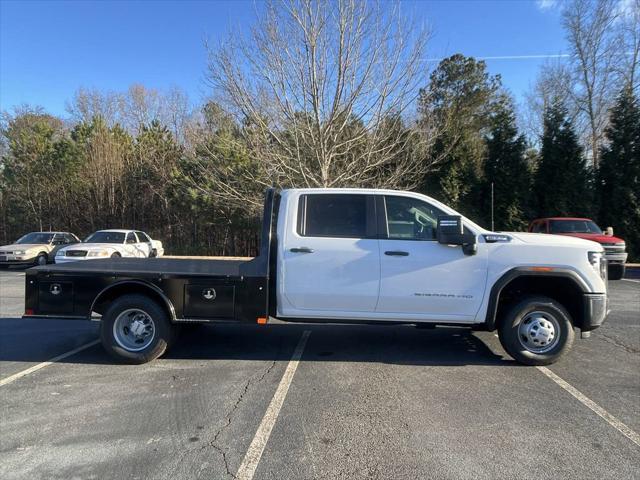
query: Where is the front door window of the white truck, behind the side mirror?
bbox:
[384,195,444,240]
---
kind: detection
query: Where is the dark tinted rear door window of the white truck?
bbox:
[297,194,374,238]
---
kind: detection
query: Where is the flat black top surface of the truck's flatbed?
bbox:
[31,257,255,277]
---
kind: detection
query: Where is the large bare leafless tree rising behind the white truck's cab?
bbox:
[201,0,428,202]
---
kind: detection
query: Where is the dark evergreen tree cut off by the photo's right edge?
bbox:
[597,88,640,260]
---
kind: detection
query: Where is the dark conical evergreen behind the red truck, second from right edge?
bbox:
[534,102,591,217]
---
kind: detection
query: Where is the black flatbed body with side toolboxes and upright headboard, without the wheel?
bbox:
[24,188,278,323]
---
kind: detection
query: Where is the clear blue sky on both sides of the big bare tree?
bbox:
[0,0,566,116]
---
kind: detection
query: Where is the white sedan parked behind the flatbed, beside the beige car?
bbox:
[55,230,164,263]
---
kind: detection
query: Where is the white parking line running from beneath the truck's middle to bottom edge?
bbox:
[235,330,311,480]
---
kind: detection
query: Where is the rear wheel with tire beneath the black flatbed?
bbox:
[100,295,175,364]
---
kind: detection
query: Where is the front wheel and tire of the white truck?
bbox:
[498,296,575,366]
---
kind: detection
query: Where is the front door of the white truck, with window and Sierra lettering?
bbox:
[376,195,487,322]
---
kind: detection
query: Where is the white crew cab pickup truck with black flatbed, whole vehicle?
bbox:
[25,189,607,365]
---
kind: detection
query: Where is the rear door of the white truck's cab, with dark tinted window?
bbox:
[278,192,380,318]
